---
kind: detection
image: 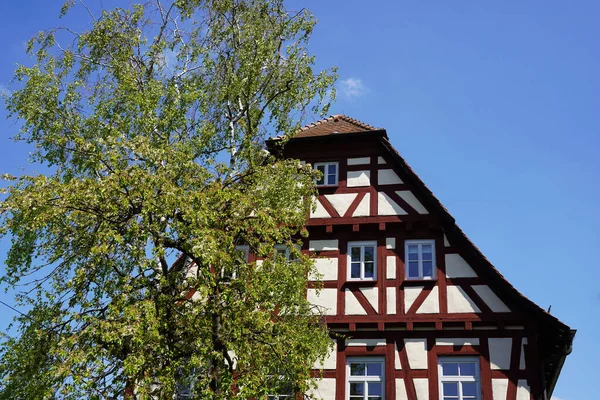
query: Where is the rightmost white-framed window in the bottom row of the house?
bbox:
[438,357,481,400]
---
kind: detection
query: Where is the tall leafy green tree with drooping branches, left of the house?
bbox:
[0,0,335,399]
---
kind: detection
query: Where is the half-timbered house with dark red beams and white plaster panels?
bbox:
[271,115,575,400]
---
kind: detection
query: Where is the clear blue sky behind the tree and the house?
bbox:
[0,0,600,400]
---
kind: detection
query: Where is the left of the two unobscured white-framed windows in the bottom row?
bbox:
[346,357,385,400]
